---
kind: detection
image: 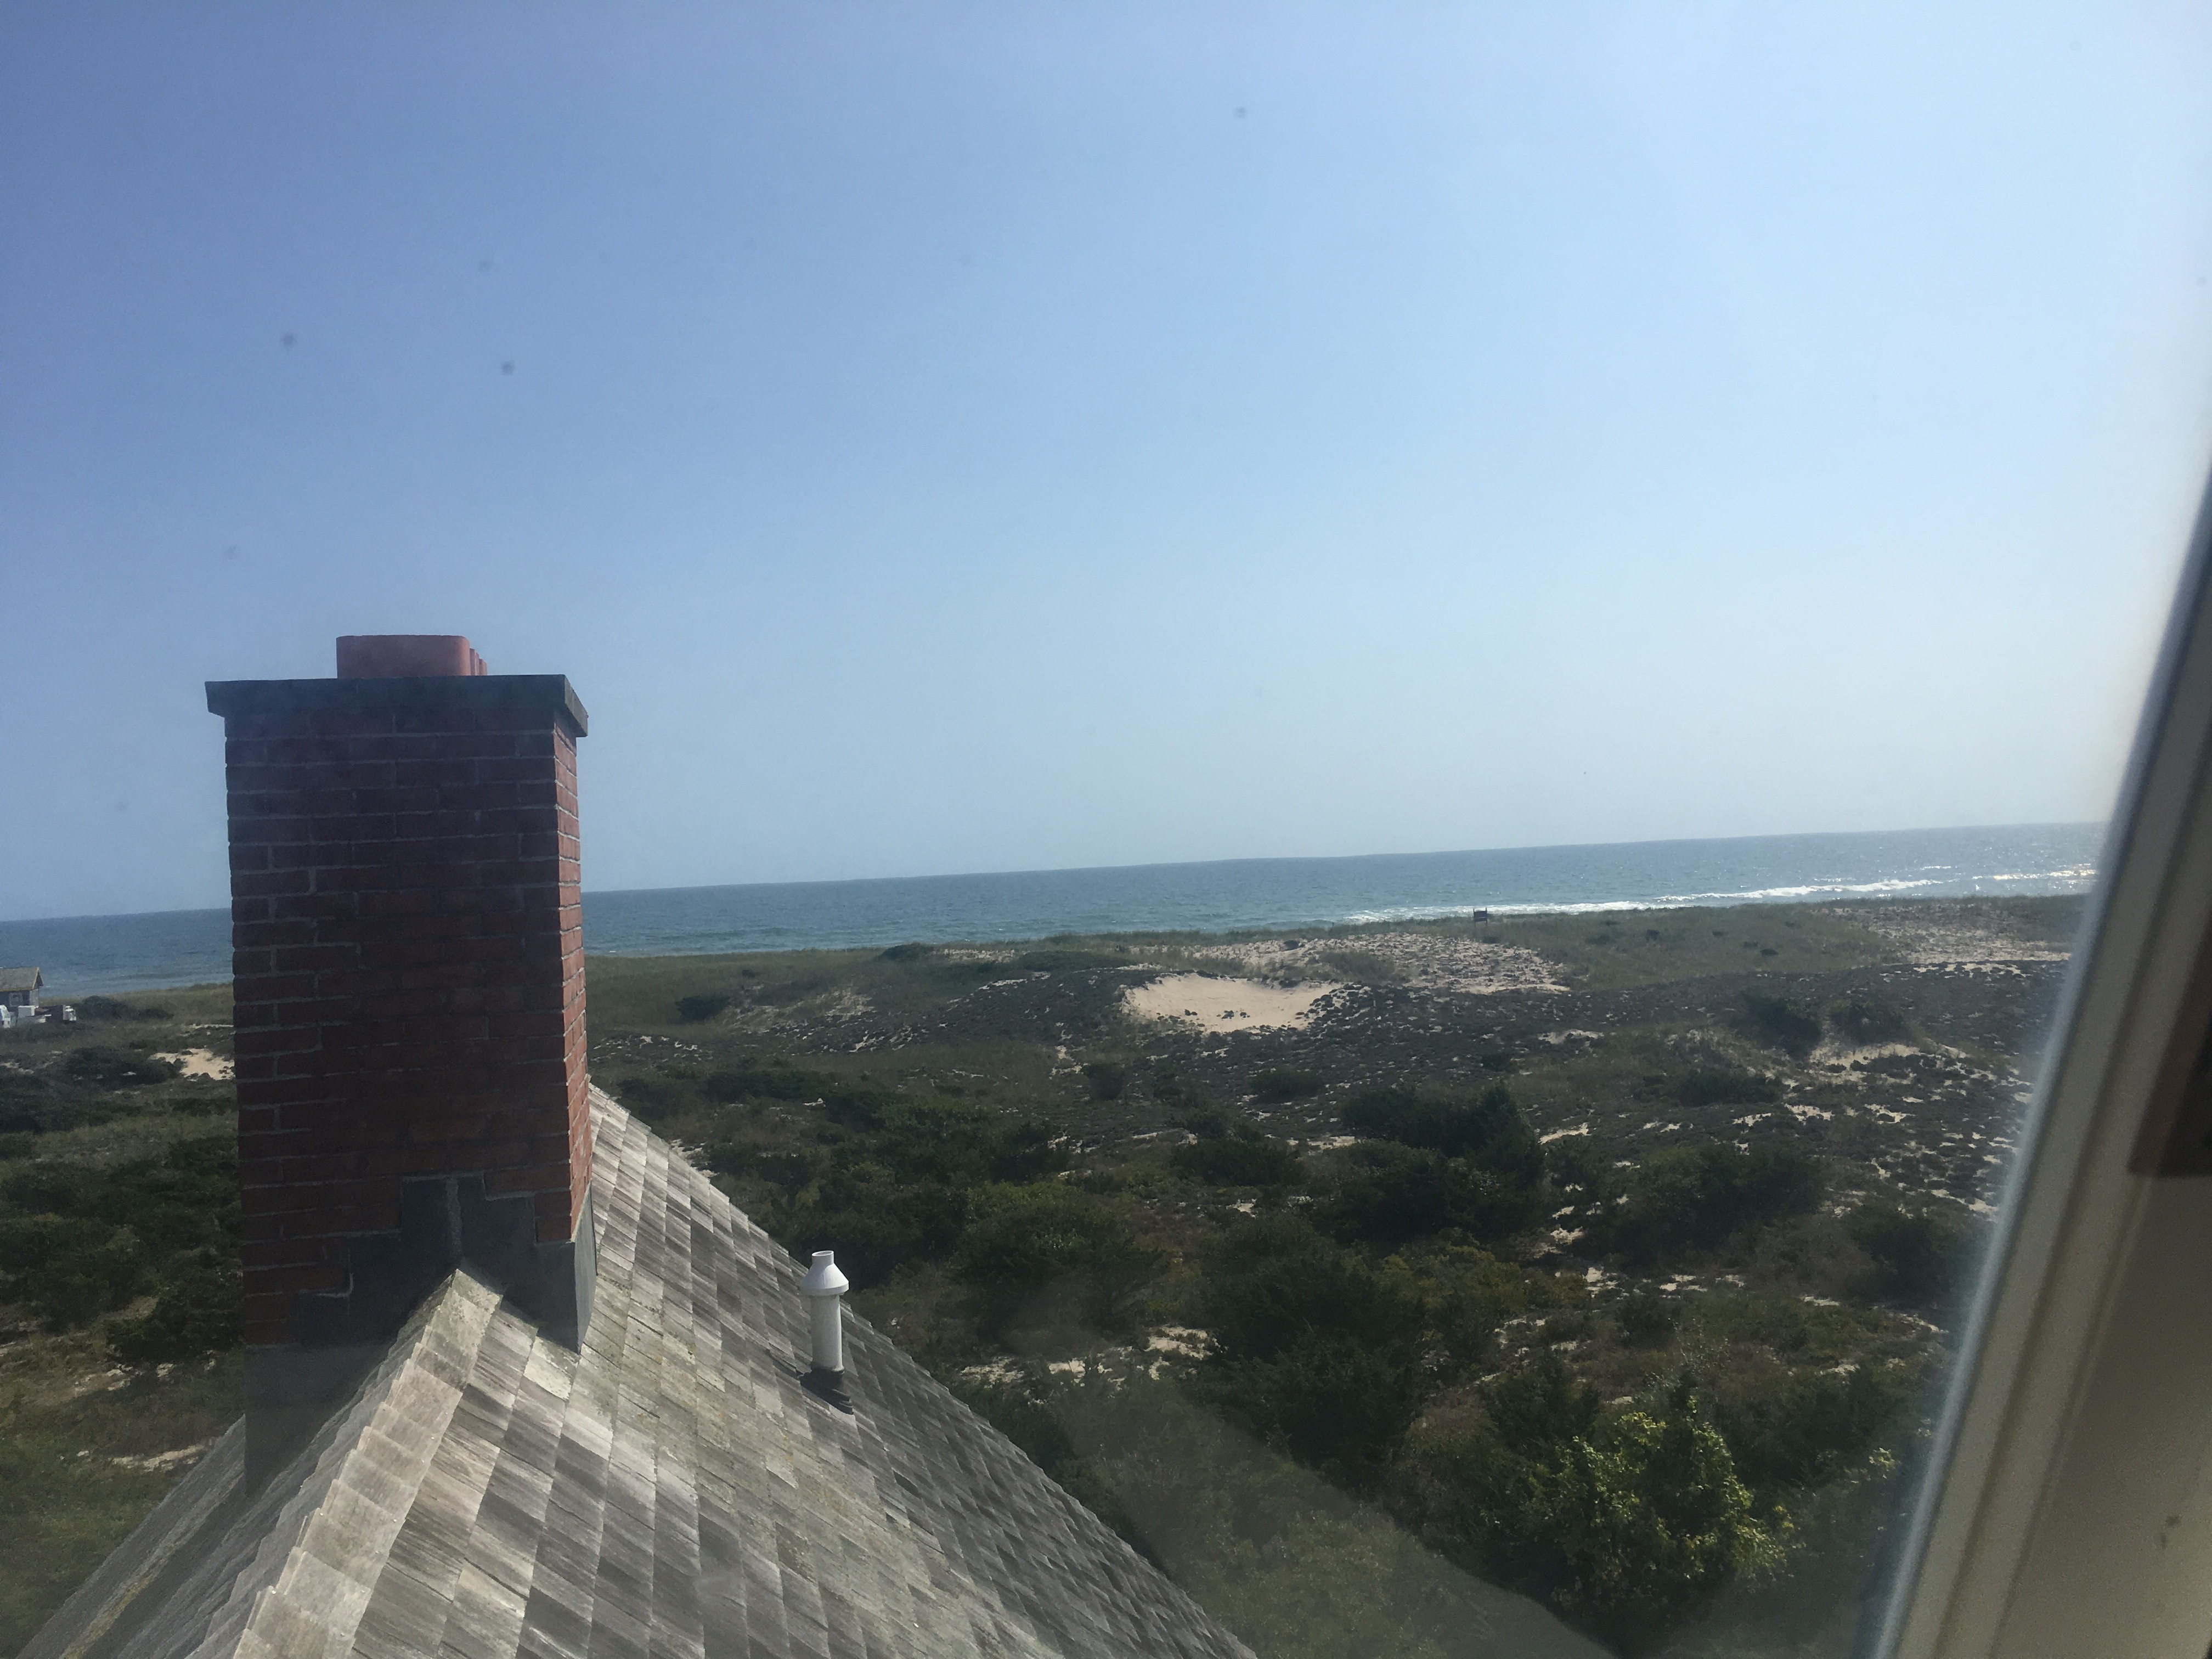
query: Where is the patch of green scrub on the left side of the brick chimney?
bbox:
[0,989,241,1652]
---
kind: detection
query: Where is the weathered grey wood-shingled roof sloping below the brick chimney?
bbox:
[24,1091,1245,1659]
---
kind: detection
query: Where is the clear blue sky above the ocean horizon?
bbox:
[0,0,2212,918]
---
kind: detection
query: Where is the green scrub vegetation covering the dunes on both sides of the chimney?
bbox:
[0,905,2066,1659]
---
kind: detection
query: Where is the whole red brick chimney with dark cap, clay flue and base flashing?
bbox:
[208,635,593,1469]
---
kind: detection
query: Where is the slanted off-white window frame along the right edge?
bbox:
[1869,471,2212,1659]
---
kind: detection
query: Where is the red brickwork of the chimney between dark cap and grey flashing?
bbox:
[225,663,591,1345]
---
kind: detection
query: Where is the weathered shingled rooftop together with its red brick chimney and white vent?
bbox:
[24,637,1248,1659]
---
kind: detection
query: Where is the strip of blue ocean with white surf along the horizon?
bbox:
[0,823,2103,995]
